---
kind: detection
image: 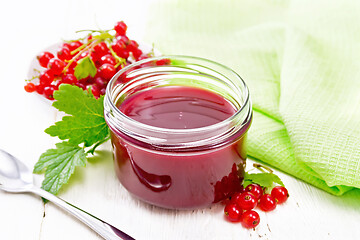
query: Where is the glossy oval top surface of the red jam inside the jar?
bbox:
[119,86,236,129]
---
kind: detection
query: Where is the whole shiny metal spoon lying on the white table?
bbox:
[0,149,134,240]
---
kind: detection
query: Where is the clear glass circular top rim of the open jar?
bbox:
[104,55,252,150]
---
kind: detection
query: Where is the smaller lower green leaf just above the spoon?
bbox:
[34,142,86,194]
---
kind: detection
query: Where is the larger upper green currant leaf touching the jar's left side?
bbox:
[45,84,109,147]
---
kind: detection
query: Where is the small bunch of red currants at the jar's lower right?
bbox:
[224,183,289,228]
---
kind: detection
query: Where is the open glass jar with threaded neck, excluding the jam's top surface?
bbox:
[104,56,252,209]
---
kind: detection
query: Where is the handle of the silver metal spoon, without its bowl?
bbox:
[30,187,135,240]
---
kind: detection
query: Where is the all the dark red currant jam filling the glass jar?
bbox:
[111,86,250,209]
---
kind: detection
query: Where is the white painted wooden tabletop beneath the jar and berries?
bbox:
[0,0,360,240]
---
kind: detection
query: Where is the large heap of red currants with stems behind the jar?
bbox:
[24,21,151,100]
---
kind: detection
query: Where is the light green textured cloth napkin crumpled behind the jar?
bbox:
[146,0,360,195]
